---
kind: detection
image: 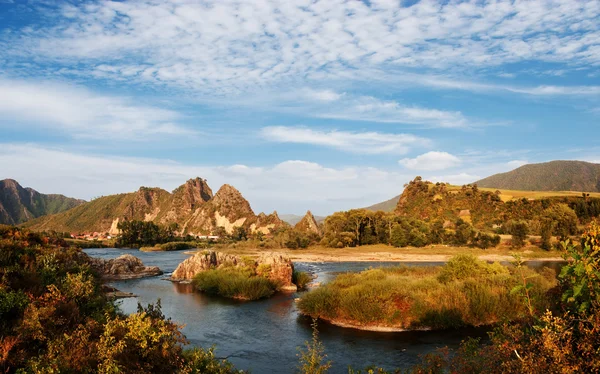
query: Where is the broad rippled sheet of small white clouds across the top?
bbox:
[5,0,600,93]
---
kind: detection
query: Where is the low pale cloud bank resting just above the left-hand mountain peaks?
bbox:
[0,143,414,214]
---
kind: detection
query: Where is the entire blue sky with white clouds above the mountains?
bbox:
[0,0,600,215]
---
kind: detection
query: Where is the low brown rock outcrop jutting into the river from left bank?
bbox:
[89,254,163,280]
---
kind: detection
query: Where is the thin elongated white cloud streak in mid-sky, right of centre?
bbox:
[261,126,431,154]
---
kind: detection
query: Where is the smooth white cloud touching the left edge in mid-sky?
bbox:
[0,80,192,140]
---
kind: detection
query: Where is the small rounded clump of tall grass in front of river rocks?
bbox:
[192,268,276,300]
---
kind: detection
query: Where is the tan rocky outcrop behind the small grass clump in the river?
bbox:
[171,251,297,292]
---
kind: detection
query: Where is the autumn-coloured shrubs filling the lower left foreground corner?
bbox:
[0,226,244,374]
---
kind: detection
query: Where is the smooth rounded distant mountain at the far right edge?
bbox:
[475,161,600,192]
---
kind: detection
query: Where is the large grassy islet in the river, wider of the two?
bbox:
[298,255,556,329]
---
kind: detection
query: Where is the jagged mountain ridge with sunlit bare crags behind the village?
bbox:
[25,178,285,235]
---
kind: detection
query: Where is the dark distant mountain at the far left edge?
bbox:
[0,179,85,225]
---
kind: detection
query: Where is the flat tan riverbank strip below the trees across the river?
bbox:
[186,244,564,262]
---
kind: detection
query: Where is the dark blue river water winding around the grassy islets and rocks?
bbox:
[85,248,564,373]
